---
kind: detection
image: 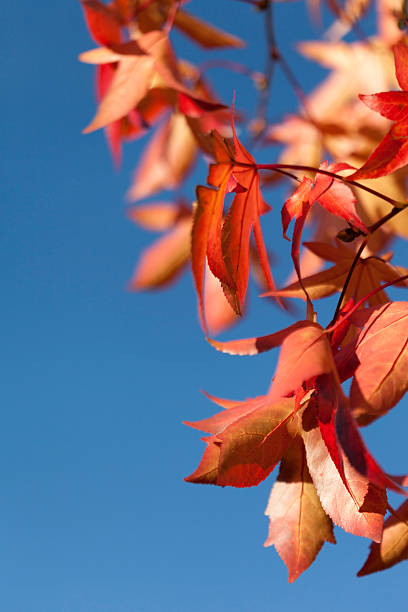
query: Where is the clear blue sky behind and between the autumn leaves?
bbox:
[0,0,407,612]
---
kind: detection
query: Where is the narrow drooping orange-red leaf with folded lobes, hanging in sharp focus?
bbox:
[192,127,275,329]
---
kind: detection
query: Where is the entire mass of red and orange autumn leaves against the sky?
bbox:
[80,0,408,581]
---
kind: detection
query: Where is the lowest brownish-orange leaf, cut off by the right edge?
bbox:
[357,501,408,576]
